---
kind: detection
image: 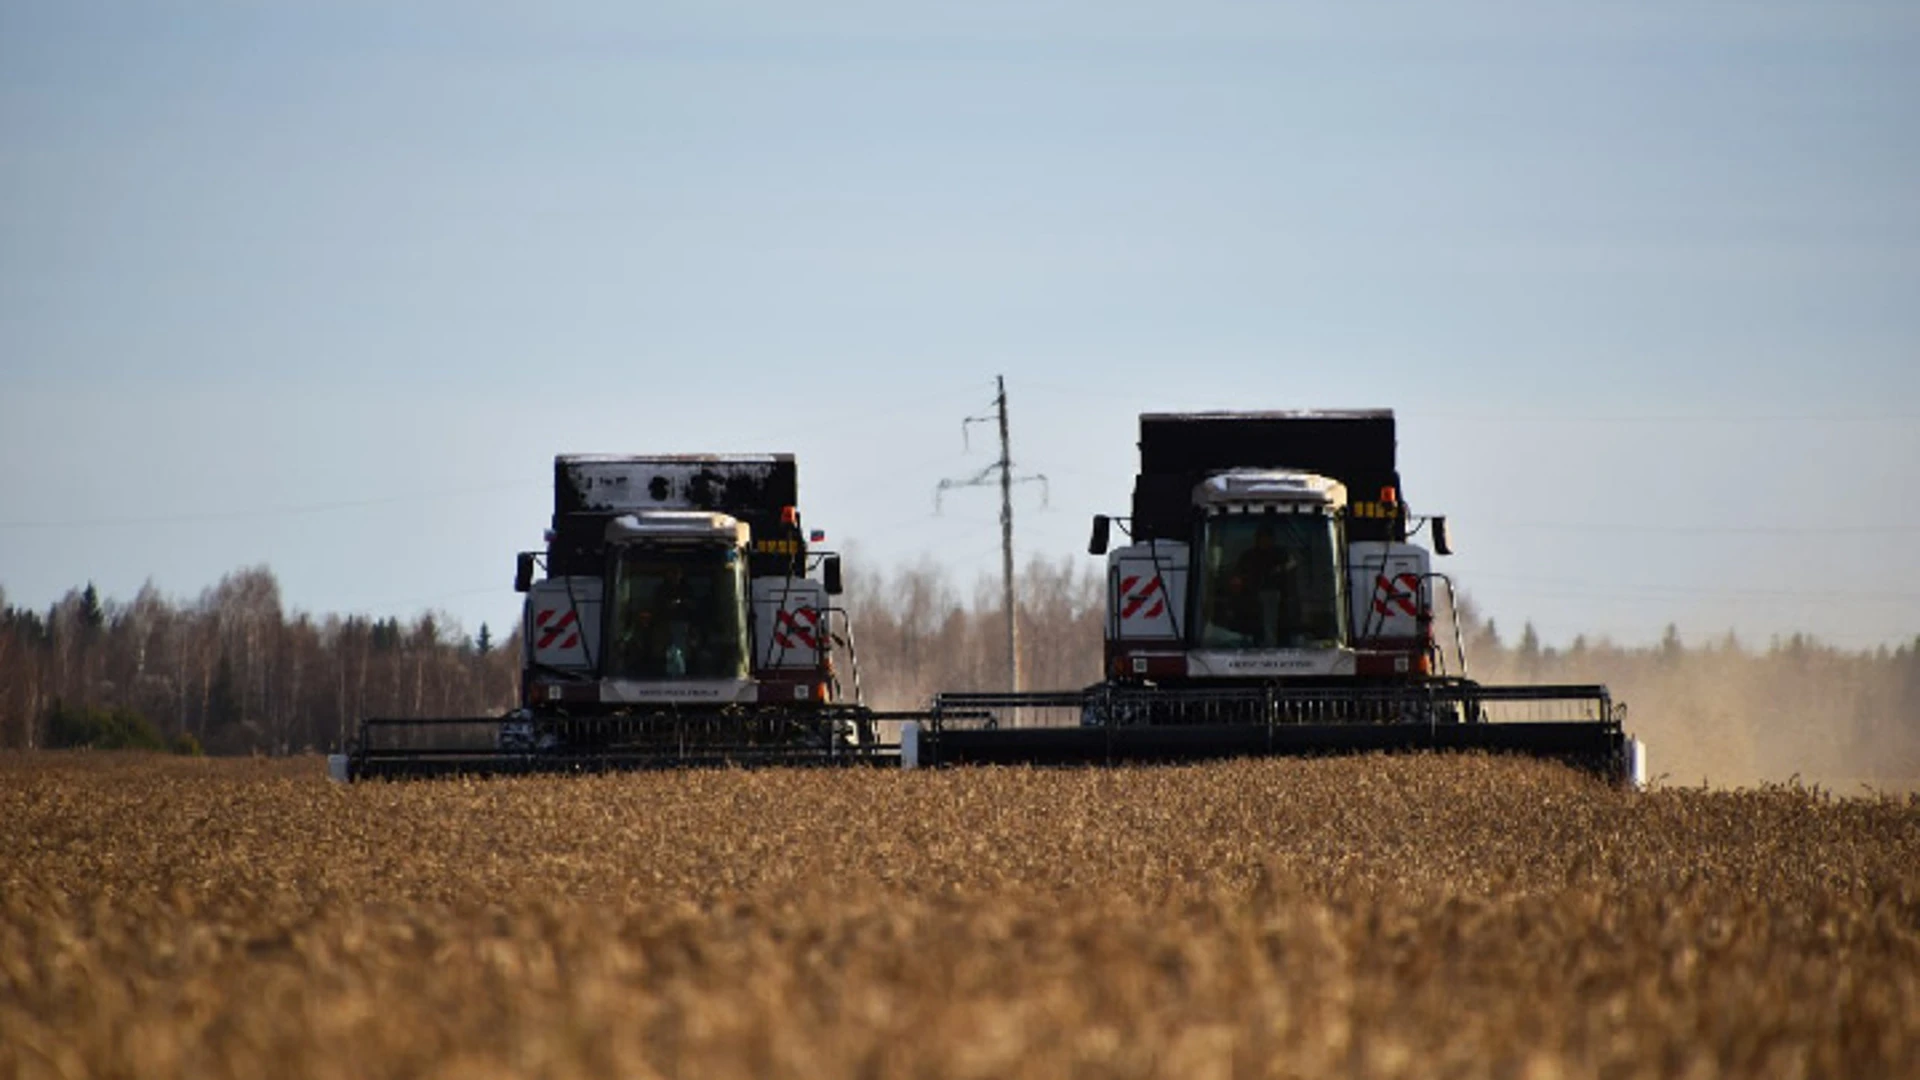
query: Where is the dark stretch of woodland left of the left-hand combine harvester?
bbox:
[0,567,518,753]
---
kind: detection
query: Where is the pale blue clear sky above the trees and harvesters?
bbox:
[0,0,1920,646]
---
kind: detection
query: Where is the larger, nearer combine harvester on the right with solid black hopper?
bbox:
[900,409,1645,786]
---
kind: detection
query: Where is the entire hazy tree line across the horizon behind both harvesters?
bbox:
[0,557,1920,782]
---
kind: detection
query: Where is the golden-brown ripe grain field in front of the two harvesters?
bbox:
[0,755,1920,1078]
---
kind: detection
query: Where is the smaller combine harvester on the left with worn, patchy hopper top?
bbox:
[343,454,881,778]
